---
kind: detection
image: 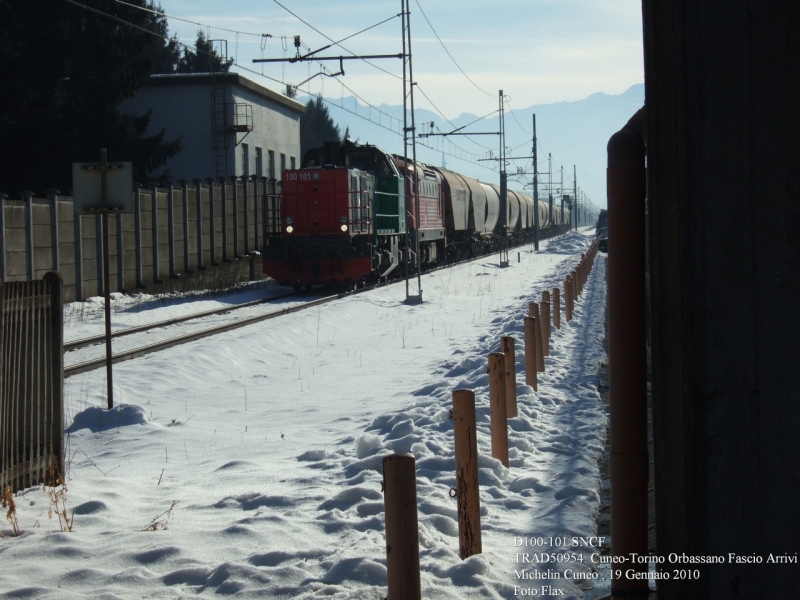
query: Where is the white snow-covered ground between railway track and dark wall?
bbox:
[0,230,607,599]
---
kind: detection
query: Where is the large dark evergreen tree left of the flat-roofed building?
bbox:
[0,0,181,194]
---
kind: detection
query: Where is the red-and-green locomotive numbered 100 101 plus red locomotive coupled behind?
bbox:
[262,141,446,288]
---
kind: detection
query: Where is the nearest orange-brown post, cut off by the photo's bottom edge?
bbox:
[383,454,422,600]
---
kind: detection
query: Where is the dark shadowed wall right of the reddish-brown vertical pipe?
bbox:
[643,0,800,600]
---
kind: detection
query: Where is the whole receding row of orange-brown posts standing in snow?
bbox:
[383,243,597,600]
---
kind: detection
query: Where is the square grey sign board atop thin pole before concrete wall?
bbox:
[72,162,133,214]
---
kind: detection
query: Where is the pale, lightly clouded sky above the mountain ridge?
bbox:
[161,0,644,119]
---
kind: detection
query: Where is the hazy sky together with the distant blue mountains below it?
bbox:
[152,0,644,208]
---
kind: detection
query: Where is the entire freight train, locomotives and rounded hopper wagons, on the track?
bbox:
[262,141,570,289]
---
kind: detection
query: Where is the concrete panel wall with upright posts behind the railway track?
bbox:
[3,182,270,302]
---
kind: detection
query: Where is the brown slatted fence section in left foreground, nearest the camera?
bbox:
[0,271,64,491]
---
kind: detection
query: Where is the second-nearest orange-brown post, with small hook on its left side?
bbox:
[450,390,482,560]
